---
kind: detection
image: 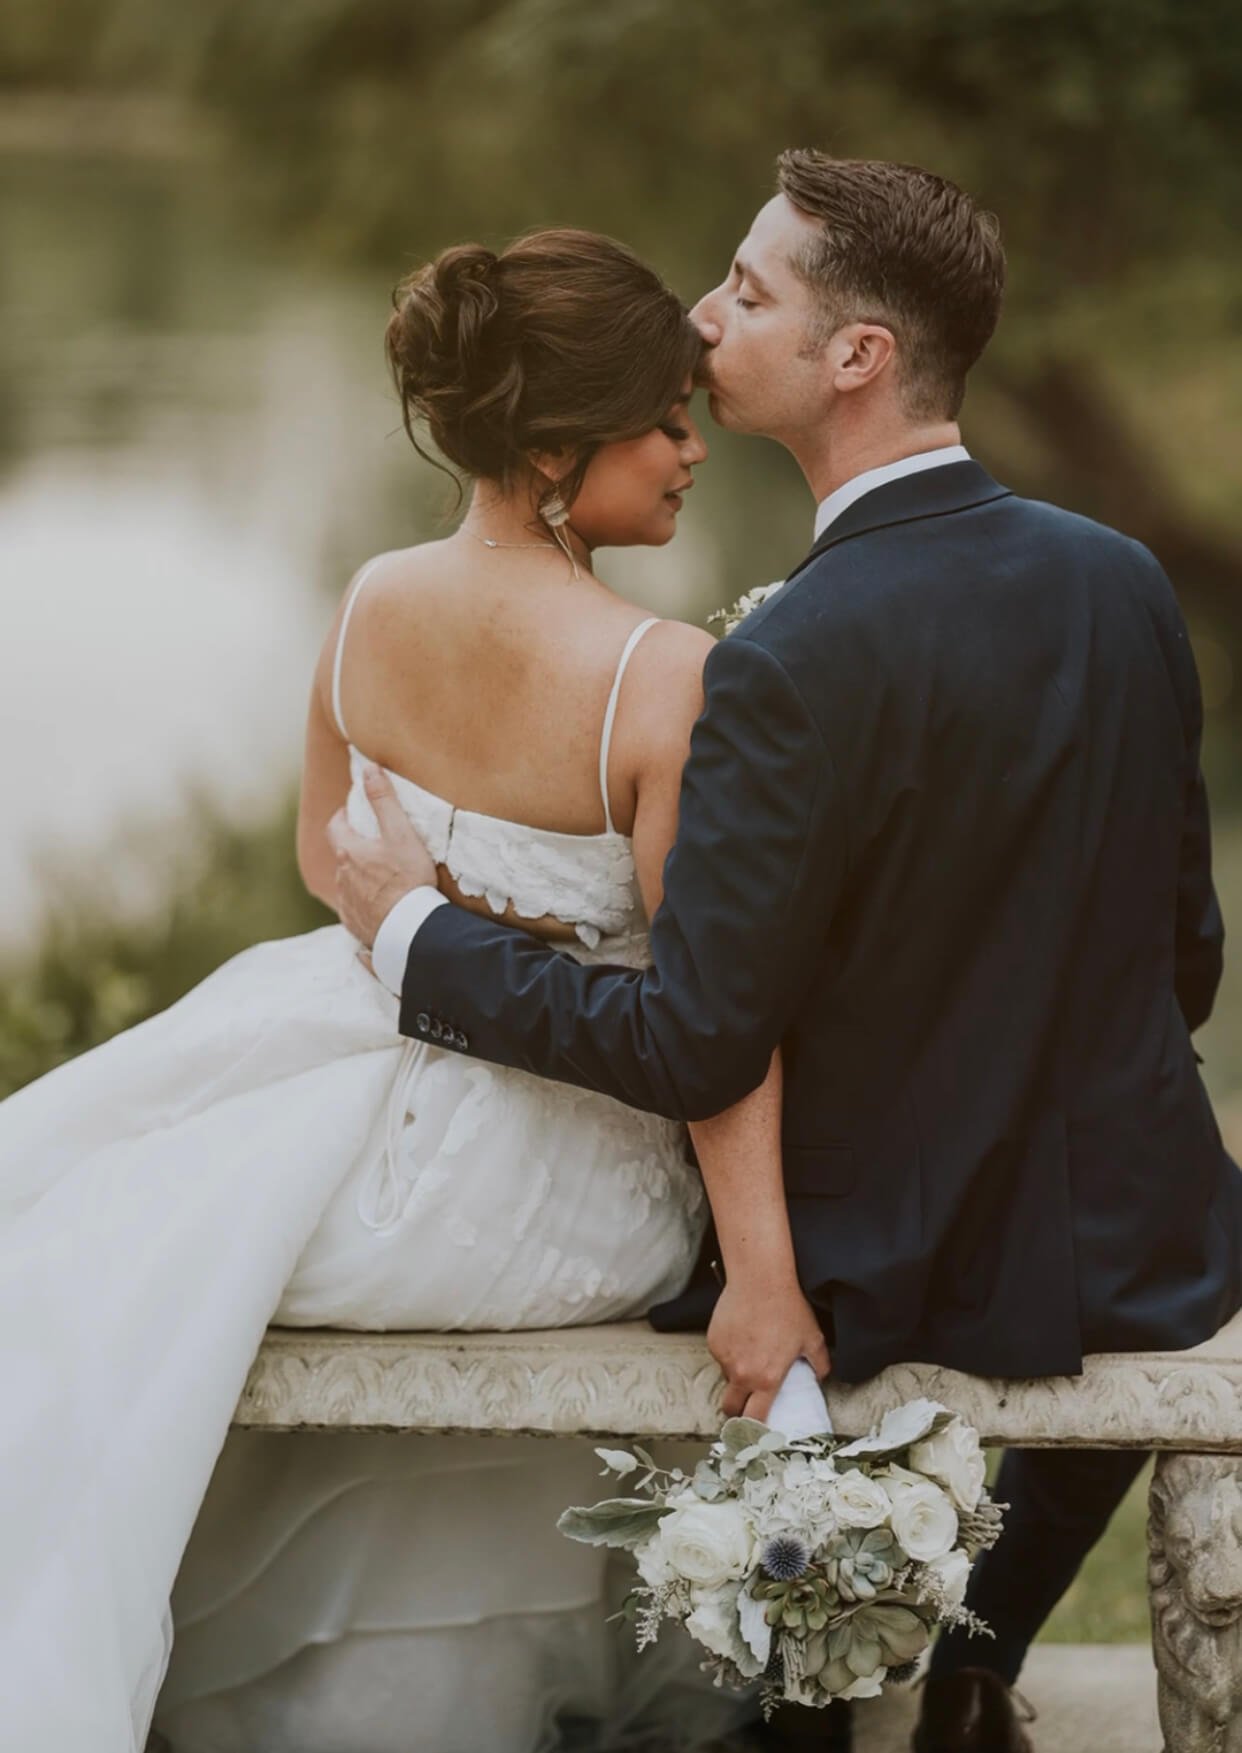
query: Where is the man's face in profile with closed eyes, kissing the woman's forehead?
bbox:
[691,195,832,442]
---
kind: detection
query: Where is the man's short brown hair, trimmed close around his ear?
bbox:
[777,147,1005,419]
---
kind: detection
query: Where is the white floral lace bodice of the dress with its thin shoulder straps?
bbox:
[332,556,656,966]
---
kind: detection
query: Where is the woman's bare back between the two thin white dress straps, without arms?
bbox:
[342,542,646,834]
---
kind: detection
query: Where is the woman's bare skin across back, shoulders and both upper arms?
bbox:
[298,533,710,938]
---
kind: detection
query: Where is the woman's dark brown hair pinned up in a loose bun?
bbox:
[384,230,702,505]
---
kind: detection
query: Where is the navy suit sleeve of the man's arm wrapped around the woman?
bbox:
[402,635,846,1120]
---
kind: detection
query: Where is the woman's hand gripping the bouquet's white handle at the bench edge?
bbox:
[707,1278,832,1422]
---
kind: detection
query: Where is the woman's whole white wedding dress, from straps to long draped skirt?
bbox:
[0,575,739,1753]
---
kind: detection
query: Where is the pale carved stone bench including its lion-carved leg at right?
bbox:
[235,1311,1242,1753]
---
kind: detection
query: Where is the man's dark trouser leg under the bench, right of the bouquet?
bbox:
[932,1448,1147,1686]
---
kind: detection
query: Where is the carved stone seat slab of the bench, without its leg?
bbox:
[235,1322,1242,1453]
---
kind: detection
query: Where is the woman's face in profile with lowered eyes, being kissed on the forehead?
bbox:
[570,384,707,549]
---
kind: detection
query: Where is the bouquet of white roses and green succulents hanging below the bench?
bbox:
[558,1401,1000,1716]
